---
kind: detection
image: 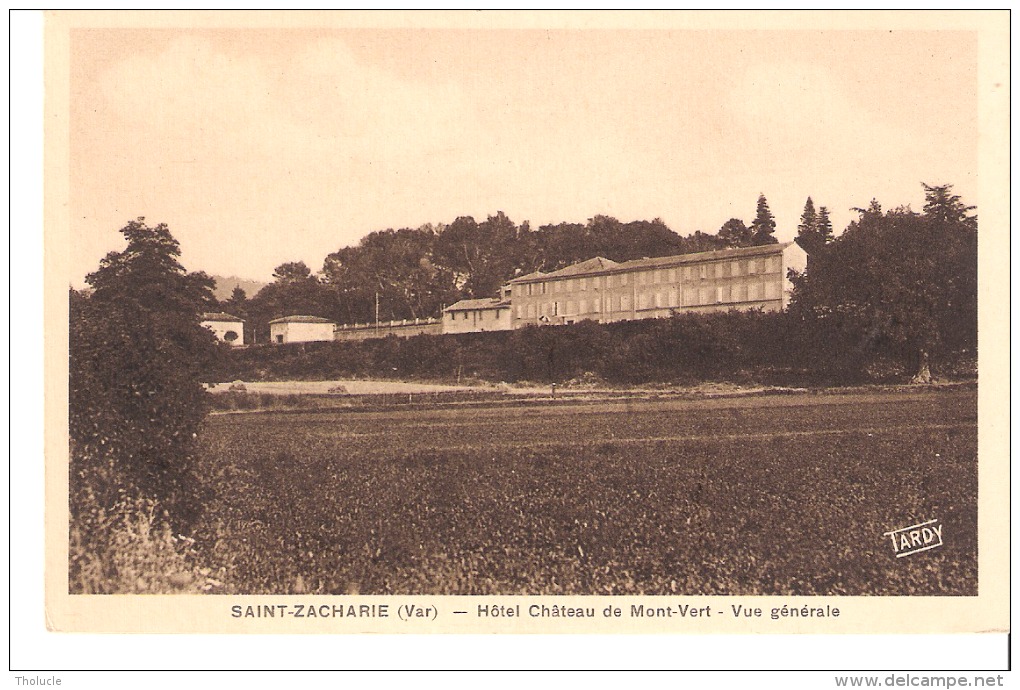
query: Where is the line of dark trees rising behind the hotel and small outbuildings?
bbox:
[218,190,776,343]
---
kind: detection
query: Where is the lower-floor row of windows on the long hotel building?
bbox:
[517,281,779,318]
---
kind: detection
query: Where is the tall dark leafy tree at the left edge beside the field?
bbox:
[68,217,216,524]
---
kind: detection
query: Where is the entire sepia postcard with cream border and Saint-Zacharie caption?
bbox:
[37,11,1010,635]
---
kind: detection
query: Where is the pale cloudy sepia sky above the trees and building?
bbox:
[69,24,978,285]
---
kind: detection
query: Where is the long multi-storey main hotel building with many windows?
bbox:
[505,242,807,329]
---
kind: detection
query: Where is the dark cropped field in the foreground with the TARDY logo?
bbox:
[197,390,977,595]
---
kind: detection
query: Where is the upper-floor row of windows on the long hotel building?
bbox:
[513,256,781,296]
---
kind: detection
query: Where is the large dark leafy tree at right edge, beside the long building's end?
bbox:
[791,188,977,383]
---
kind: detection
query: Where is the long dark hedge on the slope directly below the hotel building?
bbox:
[204,311,966,385]
